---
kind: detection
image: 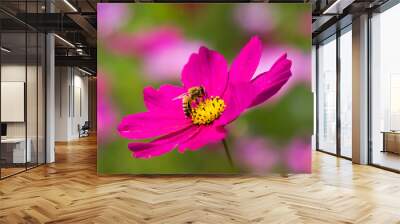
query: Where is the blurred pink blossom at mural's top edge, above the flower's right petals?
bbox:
[234,3,276,34]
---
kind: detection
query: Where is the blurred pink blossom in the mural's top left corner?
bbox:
[97,3,129,38]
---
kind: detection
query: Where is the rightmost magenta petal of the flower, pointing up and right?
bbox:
[250,54,292,107]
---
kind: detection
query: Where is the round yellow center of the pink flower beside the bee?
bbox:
[191,96,226,125]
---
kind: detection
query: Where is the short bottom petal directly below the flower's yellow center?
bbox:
[178,125,227,153]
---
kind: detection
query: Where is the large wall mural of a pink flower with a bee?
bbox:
[97,3,313,174]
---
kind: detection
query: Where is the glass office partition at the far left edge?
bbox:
[0,1,46,178]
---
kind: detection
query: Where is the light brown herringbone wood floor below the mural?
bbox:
[0,137,400,224]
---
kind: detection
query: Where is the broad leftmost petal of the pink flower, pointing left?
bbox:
[118,111,192,139]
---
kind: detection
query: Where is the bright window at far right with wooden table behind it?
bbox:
[370,1,400,170]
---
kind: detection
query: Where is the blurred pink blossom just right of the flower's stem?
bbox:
[234,138,279,174]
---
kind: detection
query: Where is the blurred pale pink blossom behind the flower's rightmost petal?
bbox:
[255,45,311,101]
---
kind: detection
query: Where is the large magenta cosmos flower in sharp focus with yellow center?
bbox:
[118,37,291,158]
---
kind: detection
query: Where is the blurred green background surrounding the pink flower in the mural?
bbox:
[97,3,313,174]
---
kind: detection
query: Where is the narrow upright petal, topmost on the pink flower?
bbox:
[229,36,262,83]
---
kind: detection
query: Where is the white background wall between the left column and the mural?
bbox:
[55,67,88,141]
